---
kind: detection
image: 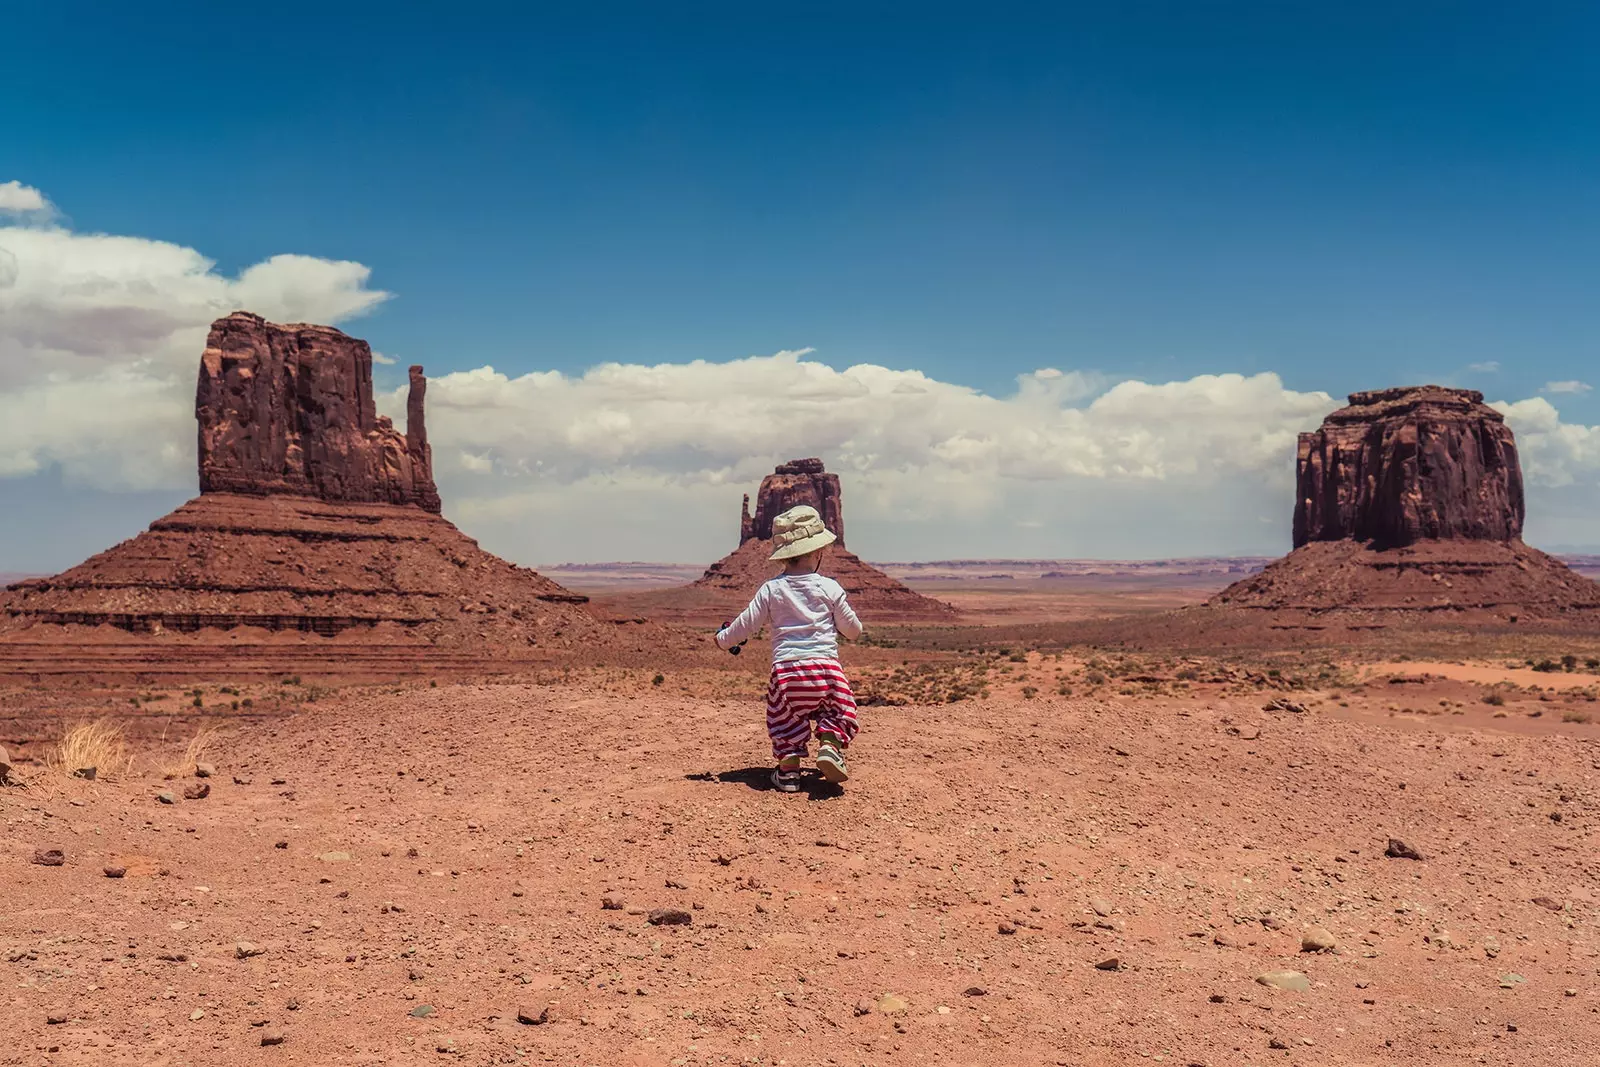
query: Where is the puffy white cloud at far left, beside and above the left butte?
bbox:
[0,182,387,490]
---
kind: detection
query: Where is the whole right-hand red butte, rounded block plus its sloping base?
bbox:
[1208,386,1600,622]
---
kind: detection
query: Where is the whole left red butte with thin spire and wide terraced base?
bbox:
[0,312,682,675]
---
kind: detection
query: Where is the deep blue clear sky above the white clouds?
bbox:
[0,3,1600,569]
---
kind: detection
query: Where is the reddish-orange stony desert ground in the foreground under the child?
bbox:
[0,654,1600,1067]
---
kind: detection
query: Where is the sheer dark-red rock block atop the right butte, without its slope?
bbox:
[1294,386,1523,549]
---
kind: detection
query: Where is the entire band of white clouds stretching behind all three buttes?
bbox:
[0,181,1600,563]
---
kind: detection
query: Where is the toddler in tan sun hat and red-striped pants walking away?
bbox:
[717,504,862,793]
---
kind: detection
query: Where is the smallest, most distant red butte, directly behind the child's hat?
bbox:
[691,458,957,627]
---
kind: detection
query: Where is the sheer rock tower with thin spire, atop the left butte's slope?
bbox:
[195,312,440,514]
